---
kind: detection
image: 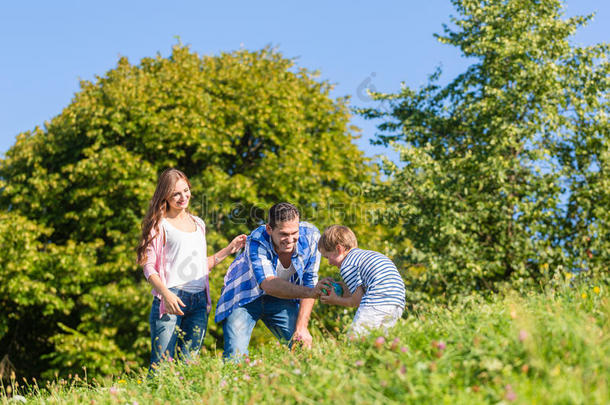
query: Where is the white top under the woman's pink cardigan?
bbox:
[161,218,208,293]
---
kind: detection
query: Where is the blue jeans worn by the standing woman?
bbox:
[149,288,208,368]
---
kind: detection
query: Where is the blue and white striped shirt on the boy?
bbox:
[341,248,405,308]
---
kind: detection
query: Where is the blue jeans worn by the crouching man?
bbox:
[222,295,299,358]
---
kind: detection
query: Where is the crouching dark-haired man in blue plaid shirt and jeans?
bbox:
[215,203,321,358]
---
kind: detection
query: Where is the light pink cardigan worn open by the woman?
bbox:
[142,215,212,317]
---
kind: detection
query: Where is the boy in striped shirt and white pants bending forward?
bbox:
[318,225,405,336]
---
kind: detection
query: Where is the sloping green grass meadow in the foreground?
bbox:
[0,285,610,404]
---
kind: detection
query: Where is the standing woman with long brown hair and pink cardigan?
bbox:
[137,169,246,369]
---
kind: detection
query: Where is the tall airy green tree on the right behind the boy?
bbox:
[362,0,610,299]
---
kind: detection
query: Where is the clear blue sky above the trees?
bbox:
[0,0,610,156]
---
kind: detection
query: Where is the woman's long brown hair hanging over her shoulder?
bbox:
[137,169,191,264]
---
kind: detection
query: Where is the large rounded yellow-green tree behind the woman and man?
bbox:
[0,45,373,376]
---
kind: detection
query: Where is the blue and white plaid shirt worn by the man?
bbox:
[214,222,321,323]
